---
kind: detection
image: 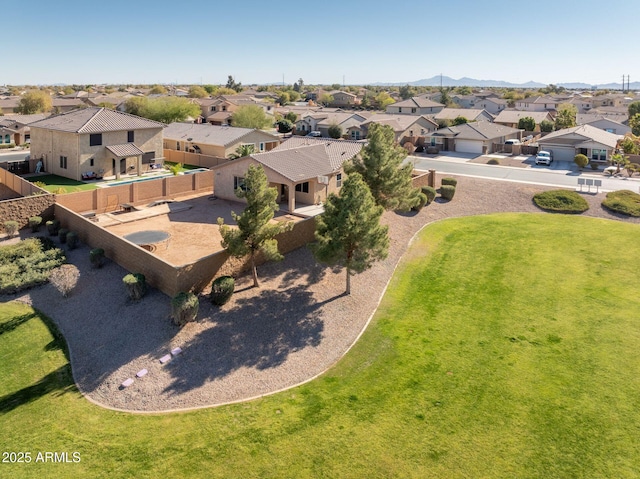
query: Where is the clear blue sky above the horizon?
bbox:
[5,0,640,85]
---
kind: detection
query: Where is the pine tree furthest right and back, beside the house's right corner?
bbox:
[345,123,420,211]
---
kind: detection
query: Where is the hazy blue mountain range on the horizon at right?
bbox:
[371,75,640,90]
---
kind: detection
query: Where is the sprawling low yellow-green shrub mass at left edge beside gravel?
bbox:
[0,238,65,294]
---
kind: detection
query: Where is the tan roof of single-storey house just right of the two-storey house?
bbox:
[163,123,279,147]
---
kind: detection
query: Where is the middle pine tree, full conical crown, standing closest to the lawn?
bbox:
[311,173,389,294]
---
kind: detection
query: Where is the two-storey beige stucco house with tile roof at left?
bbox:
[29,107,164,181]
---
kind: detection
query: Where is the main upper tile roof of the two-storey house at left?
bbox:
[30,107,164,133]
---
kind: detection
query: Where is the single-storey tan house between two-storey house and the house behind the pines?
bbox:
[163,123,280,158]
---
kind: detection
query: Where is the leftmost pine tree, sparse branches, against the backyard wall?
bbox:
[218,165,293,287]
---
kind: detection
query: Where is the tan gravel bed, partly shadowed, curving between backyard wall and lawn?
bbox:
[0,177,640,412]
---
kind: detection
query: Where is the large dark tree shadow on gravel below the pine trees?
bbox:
[164,285,336,394]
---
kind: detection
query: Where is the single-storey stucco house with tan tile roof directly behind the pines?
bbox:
[214,136,362,212]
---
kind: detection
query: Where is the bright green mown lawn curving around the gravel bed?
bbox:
[0,214,640,479]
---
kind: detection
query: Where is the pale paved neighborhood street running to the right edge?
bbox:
[405,154,640,192]
